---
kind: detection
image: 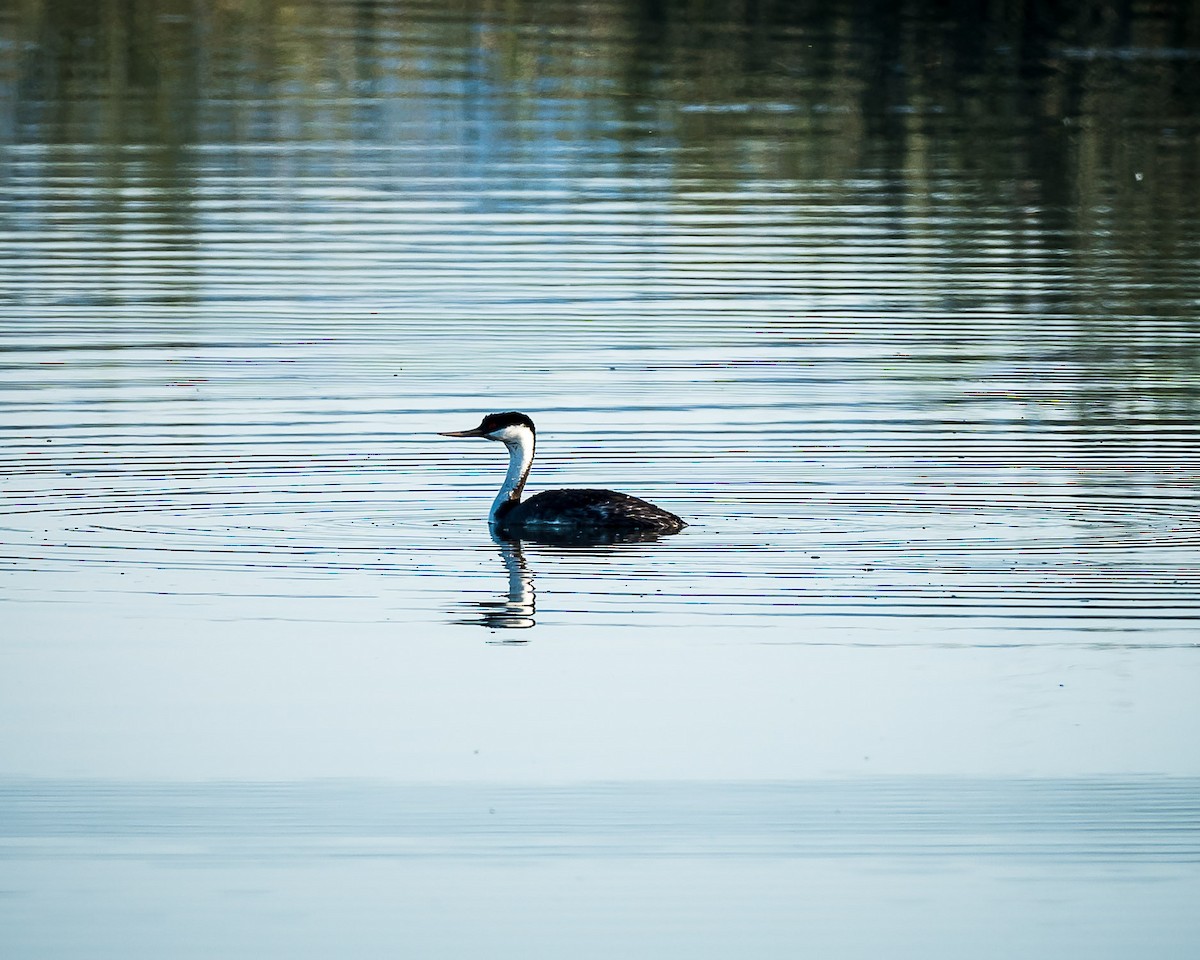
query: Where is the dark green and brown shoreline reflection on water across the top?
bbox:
[0,0,1200,427]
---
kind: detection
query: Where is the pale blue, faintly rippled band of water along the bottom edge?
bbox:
[0,778,1200,956]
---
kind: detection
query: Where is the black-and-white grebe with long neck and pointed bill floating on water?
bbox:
[439,413,688,538]
